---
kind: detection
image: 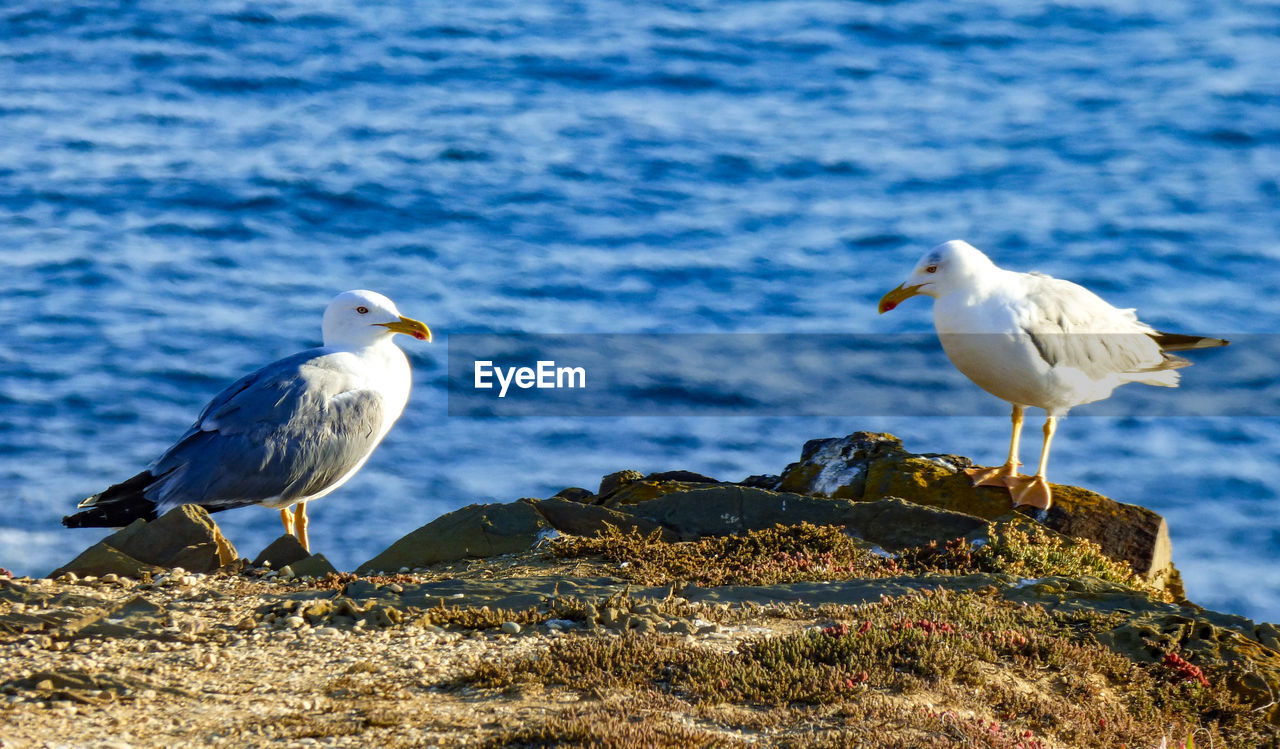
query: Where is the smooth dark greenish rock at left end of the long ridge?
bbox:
[356,499,553,575]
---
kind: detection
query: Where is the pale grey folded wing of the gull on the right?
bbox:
[1018,274,1172,379]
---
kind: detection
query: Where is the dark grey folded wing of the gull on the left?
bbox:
[145,350,383,512]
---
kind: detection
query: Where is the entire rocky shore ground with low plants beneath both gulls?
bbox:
[17,433,1280,746]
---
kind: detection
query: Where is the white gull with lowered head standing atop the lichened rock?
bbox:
[879,239,1228,511]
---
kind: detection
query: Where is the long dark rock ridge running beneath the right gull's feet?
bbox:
[357,431,1180,594]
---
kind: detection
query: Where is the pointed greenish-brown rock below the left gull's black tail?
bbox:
[50,504,237,577]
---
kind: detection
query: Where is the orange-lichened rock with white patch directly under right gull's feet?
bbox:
[778,431,1172,581]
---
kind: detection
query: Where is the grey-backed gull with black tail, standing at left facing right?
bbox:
[63,289,431,552]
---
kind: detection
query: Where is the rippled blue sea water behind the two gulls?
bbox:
[0,0,1280,621]
